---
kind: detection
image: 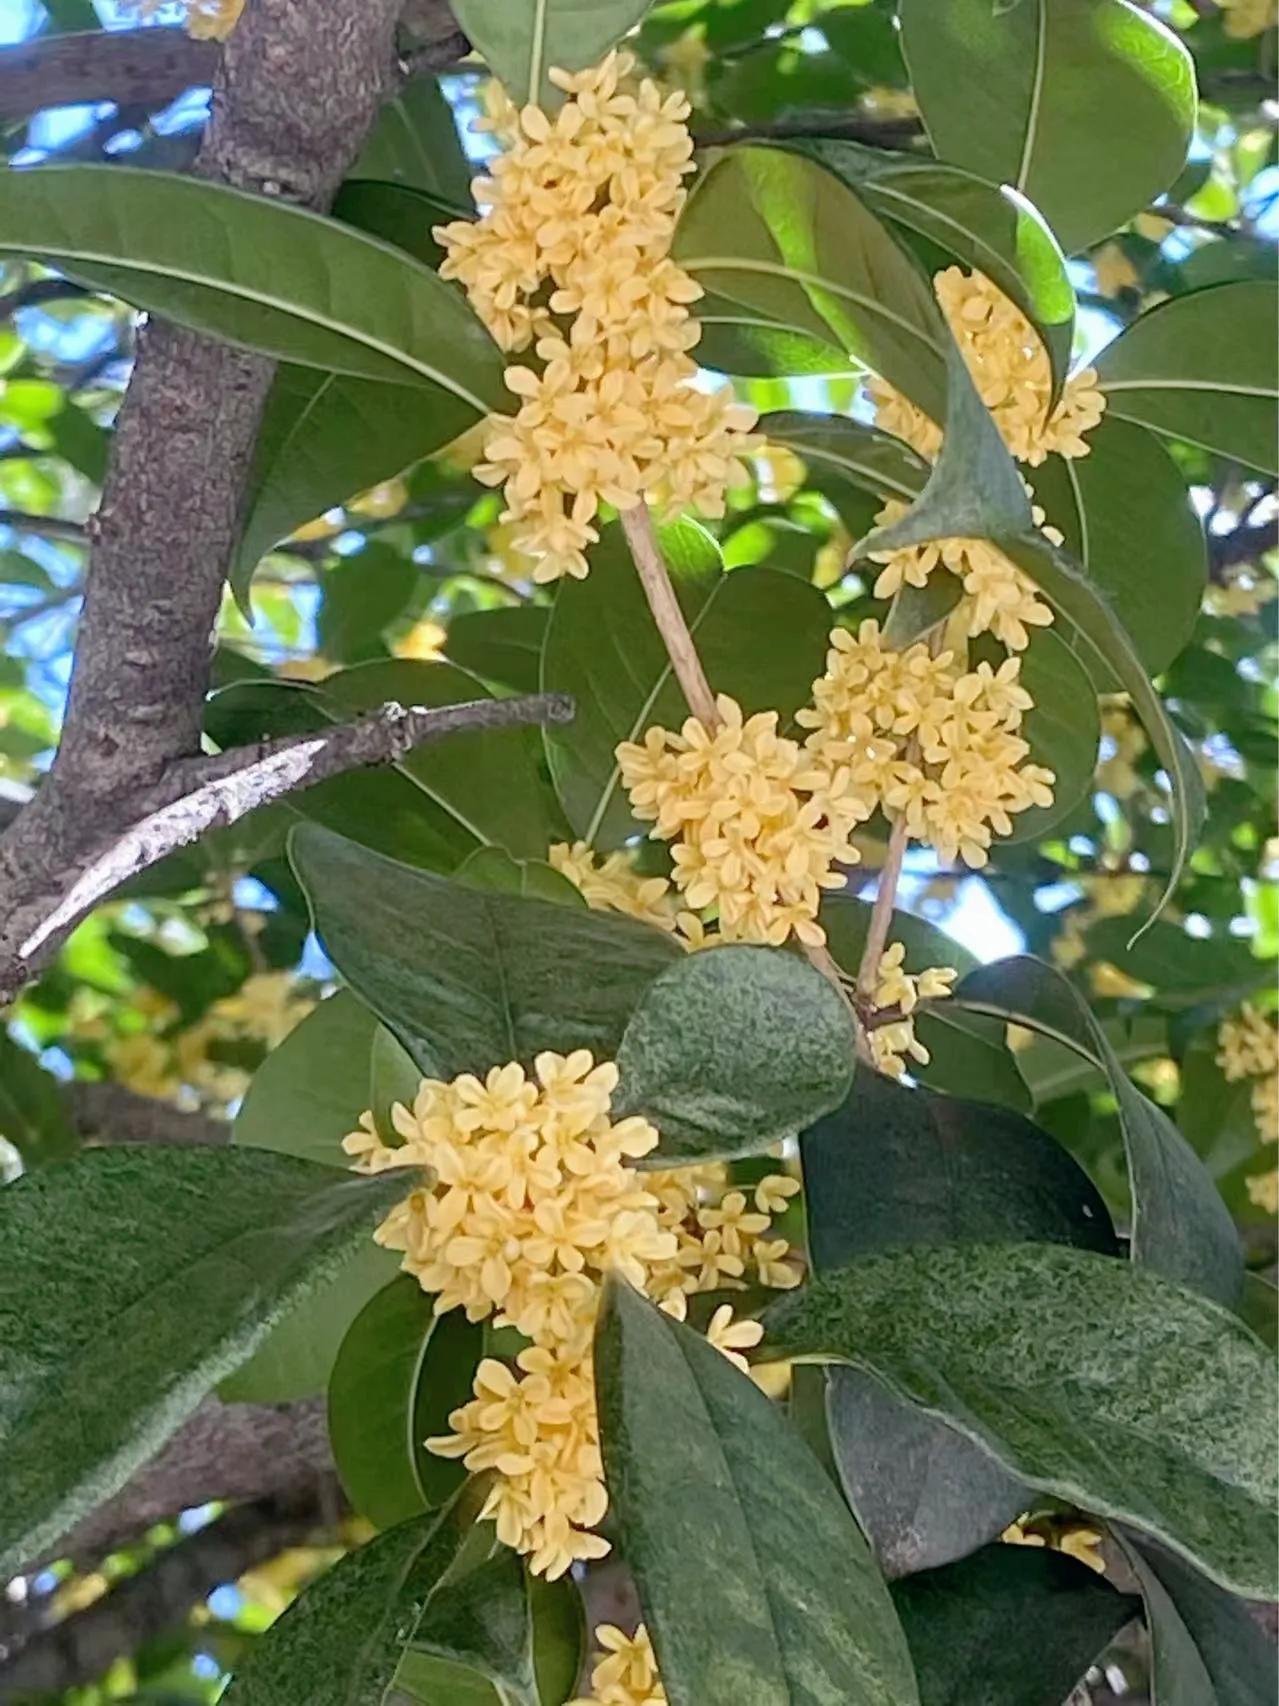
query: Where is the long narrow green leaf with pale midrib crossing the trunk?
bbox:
[0,165,505,402]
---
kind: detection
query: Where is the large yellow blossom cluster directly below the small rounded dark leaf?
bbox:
[343,1049,798,1576]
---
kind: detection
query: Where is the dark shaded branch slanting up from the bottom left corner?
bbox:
[0,1486,338,1703]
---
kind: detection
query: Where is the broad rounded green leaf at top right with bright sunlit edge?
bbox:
[899,0,1195,254]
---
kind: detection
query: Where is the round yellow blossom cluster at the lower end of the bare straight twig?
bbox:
[617,694,871,945]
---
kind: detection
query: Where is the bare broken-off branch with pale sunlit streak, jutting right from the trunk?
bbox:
[0,693,573,1000]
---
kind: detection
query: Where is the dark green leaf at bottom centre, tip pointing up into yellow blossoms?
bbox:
[595,1281,917,1706]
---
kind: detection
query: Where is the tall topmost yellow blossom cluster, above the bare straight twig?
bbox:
[435,53,755,582]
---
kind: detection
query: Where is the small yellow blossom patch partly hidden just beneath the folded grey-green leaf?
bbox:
[868,498,1062,652]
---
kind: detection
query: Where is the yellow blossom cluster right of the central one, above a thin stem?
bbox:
[798,621,1056,867]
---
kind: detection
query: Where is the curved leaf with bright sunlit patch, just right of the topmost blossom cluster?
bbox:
[672,148,946,409]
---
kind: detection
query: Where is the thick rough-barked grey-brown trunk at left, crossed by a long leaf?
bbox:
[0,0,457,991]
